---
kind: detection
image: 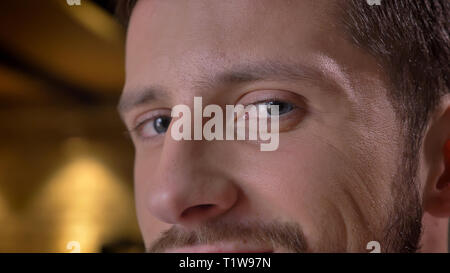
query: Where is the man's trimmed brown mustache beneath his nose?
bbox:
[146,221,308,253]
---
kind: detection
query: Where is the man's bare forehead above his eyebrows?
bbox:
[121,0,337,85]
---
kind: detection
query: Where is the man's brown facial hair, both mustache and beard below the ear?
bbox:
[146,140,423,253]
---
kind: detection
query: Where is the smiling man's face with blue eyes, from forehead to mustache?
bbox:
[122,0,422,252]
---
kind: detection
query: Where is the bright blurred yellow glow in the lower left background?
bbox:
[30,139,135,252]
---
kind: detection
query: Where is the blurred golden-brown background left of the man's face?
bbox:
[0,0,143,252]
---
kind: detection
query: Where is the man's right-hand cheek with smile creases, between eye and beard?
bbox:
[228,129,392,251]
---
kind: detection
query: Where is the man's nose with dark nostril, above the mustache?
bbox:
[148,133,238,226]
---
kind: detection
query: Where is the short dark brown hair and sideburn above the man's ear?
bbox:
[342,0,450,173]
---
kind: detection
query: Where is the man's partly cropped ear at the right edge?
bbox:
[423,95,450,218]
